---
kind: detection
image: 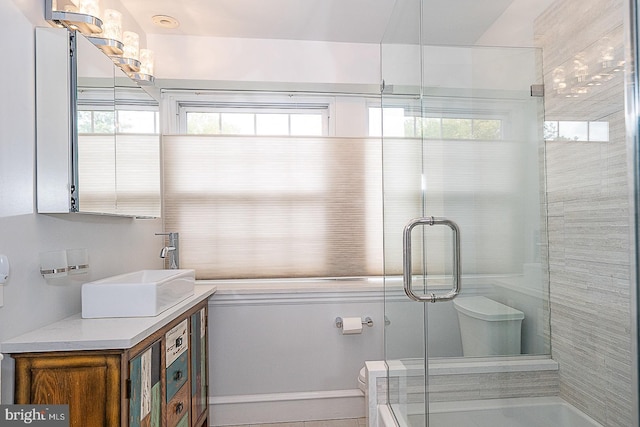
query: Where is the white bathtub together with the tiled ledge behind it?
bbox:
[363,355,602,427]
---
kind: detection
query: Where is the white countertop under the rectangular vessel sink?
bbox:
[0,284,216,353]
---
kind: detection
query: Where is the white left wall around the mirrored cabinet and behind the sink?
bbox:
[0,0,162,403]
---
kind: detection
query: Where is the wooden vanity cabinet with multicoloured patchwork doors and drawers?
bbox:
[12,299,208,427]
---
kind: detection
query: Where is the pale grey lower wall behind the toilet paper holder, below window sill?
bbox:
[209,276,548,426]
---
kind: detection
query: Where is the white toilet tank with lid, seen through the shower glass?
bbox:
[453,296,524,356]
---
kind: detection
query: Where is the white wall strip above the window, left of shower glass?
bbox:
[147,34,380,85]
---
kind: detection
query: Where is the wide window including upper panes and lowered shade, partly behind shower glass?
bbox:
[163,94,537,279]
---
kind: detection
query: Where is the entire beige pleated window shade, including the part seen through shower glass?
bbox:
[163,135,528,279]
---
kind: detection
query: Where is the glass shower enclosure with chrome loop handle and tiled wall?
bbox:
[380,0,637,427]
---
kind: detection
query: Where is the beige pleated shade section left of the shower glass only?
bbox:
[163,135,382,279]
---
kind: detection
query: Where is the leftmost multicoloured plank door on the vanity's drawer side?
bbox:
[129,341,162,427]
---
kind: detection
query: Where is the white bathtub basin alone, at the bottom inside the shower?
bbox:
[377,397,603,427]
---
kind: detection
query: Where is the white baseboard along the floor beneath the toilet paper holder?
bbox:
[209,389,365,426]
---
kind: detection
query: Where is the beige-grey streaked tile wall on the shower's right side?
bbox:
[536,0,633,427]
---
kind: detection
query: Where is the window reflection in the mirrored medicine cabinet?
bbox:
[78,105,161,216]
